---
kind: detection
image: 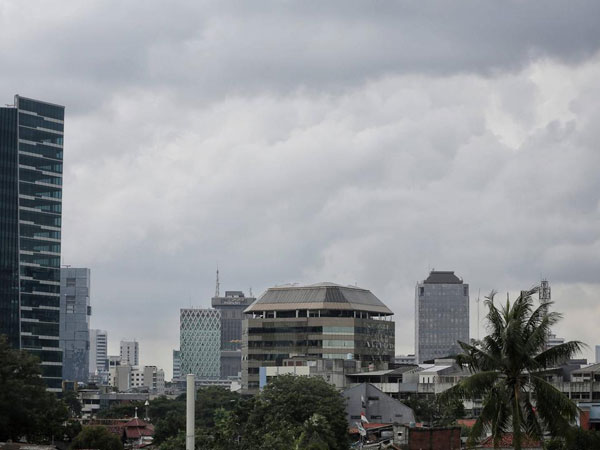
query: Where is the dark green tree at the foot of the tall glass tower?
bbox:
[0,336,68,442]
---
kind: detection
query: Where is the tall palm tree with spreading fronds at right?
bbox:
[442,287,584,450]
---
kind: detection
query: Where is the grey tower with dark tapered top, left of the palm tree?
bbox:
[415,270,469,363]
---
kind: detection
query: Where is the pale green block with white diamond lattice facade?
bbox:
[179,308,221,380]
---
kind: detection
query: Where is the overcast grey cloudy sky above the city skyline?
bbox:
[0,0,600,379]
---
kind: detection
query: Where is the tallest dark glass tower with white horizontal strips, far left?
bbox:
[0,95,65,391]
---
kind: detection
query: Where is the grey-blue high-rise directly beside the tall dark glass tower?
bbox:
[60,267,92,383]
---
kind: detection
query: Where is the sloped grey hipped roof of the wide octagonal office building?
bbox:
[245,283,393,316]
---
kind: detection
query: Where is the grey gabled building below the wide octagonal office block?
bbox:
[342,383,415,425]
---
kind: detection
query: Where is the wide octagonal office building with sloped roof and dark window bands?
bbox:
[242,283,395,393]
